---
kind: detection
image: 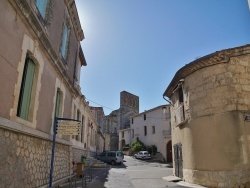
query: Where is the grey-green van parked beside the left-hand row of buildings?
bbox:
[96,151,124,165]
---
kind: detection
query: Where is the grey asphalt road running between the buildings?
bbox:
[62,156,205,188]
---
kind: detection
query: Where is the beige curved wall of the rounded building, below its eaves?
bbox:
[171,55,250,187]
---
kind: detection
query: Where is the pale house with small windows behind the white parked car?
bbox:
[129,105,172,162]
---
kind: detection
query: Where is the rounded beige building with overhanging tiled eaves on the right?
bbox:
[163,45,250,187]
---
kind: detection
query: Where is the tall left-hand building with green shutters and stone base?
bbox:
[0,0,97,188]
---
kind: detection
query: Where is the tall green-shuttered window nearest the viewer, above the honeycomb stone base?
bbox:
[17,56,35,120]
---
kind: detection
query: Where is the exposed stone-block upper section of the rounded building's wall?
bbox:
[187,55,250,119]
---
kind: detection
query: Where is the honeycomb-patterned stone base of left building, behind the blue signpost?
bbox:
[0,128,69,188]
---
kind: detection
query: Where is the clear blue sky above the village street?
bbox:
[76,0,250,115]
